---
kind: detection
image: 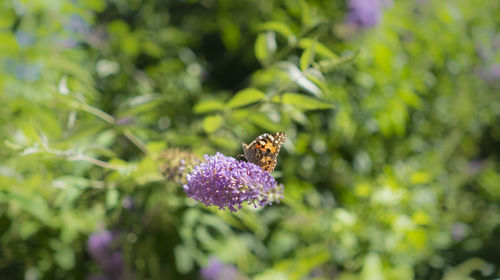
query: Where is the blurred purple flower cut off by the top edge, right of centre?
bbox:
[346,0,384,28]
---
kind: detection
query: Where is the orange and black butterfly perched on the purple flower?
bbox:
[239,132,286,172]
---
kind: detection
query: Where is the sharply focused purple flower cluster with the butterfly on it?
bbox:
[184,153,283,212]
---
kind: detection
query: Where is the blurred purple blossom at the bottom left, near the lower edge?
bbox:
[87,230,125,280]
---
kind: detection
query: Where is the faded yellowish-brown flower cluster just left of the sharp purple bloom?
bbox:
[158,149,201,184]
